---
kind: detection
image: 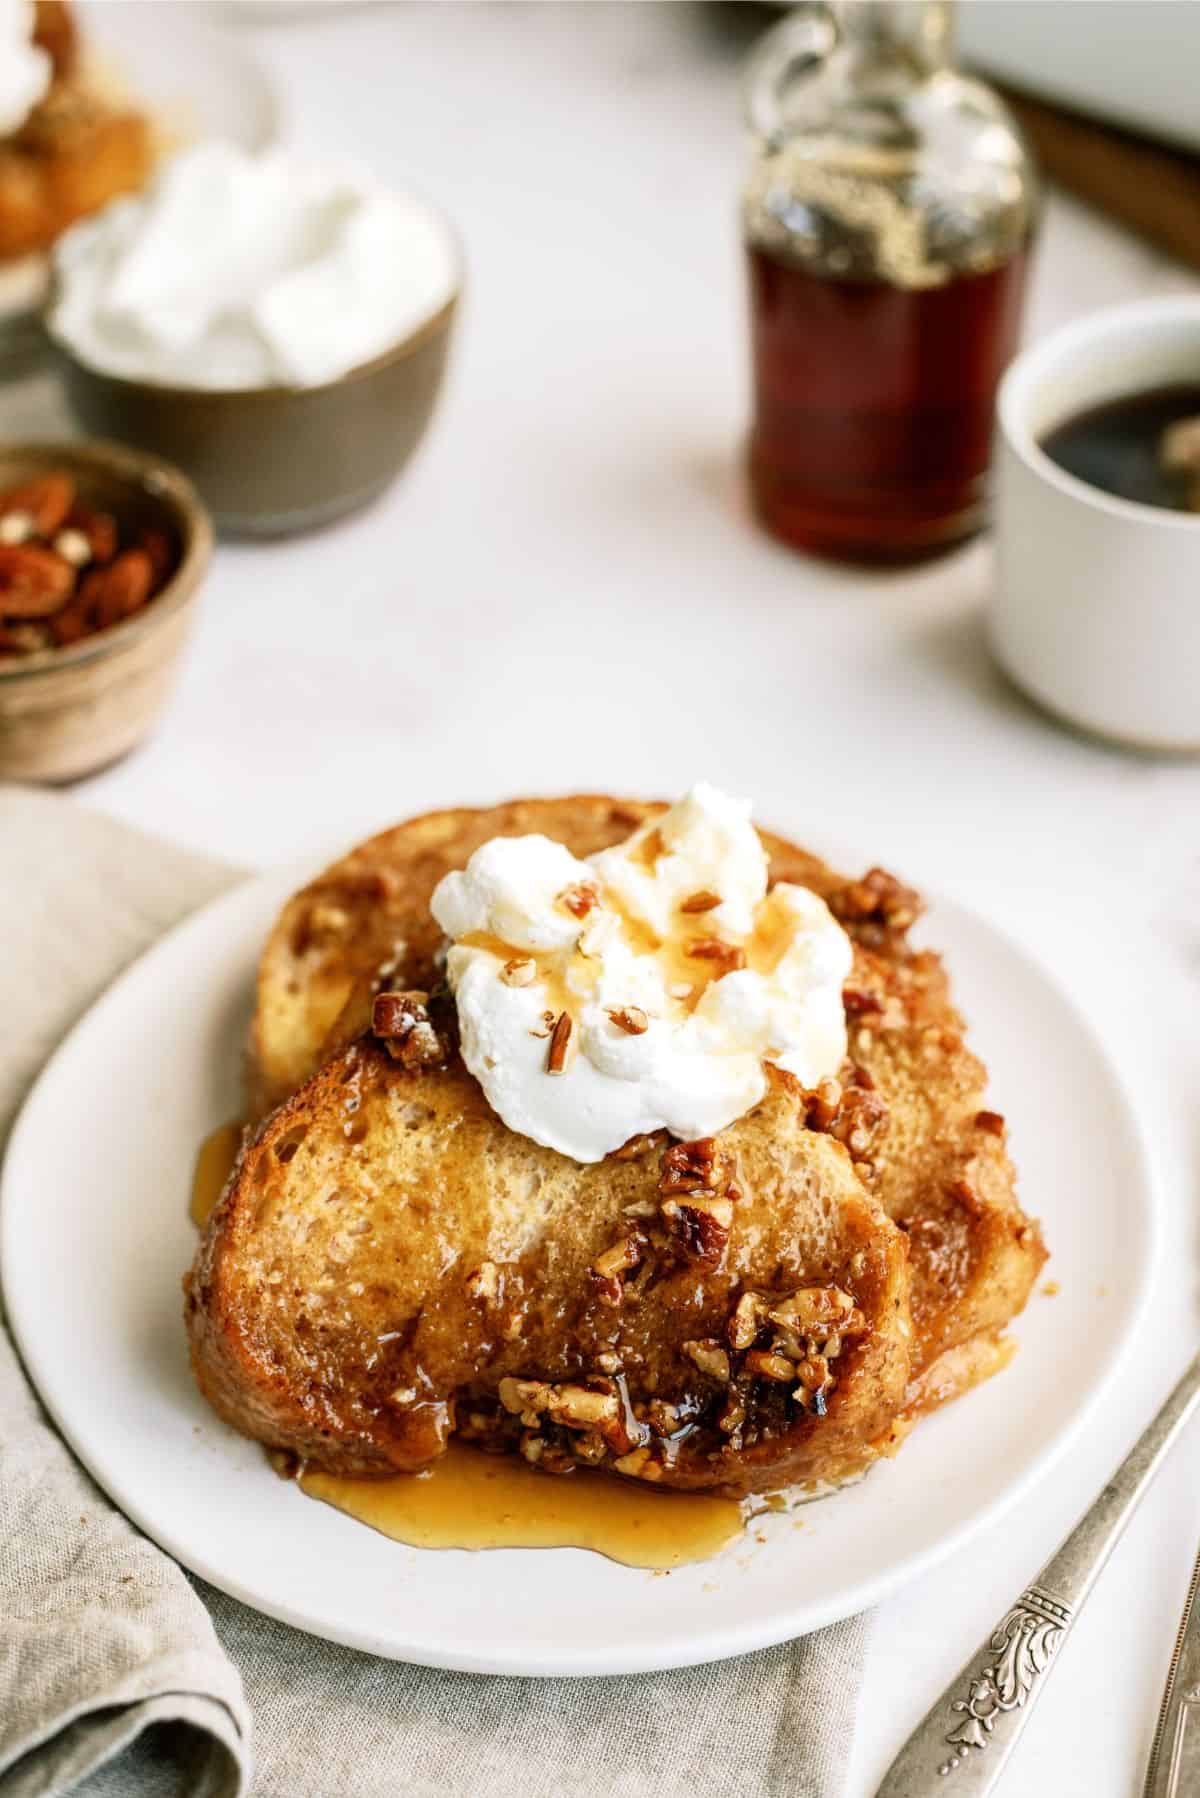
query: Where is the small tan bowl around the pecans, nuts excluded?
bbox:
[0,442,212,782]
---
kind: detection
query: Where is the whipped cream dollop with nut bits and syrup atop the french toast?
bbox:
[432,784,853,1162]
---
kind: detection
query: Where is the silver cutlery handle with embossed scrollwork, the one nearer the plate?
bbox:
[876,1356,1200,1798]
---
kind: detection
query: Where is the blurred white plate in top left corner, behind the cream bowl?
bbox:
[0,0,279,332]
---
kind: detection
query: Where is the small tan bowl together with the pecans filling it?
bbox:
[0,442,212,782]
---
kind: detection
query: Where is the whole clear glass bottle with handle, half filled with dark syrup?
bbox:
[743,0,1036,561]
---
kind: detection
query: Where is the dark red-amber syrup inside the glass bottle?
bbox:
[748,248,1025,561]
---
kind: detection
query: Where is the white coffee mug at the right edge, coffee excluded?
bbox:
[988,297,1200,750]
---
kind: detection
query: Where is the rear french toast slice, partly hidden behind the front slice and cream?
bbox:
[248,795,1045,1408]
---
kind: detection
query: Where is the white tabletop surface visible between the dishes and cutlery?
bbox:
[11,4,1200,1798]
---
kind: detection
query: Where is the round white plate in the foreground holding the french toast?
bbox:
[0,874,1153,1674]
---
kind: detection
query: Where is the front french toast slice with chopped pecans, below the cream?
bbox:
[185,1037,912,1494]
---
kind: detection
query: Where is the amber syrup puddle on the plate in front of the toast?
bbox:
[299,1442,743,1570]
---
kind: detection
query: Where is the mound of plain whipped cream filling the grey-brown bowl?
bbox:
[50,142,457,388]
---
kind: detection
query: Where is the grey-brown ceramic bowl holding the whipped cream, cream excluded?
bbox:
[50,277,459,536]
